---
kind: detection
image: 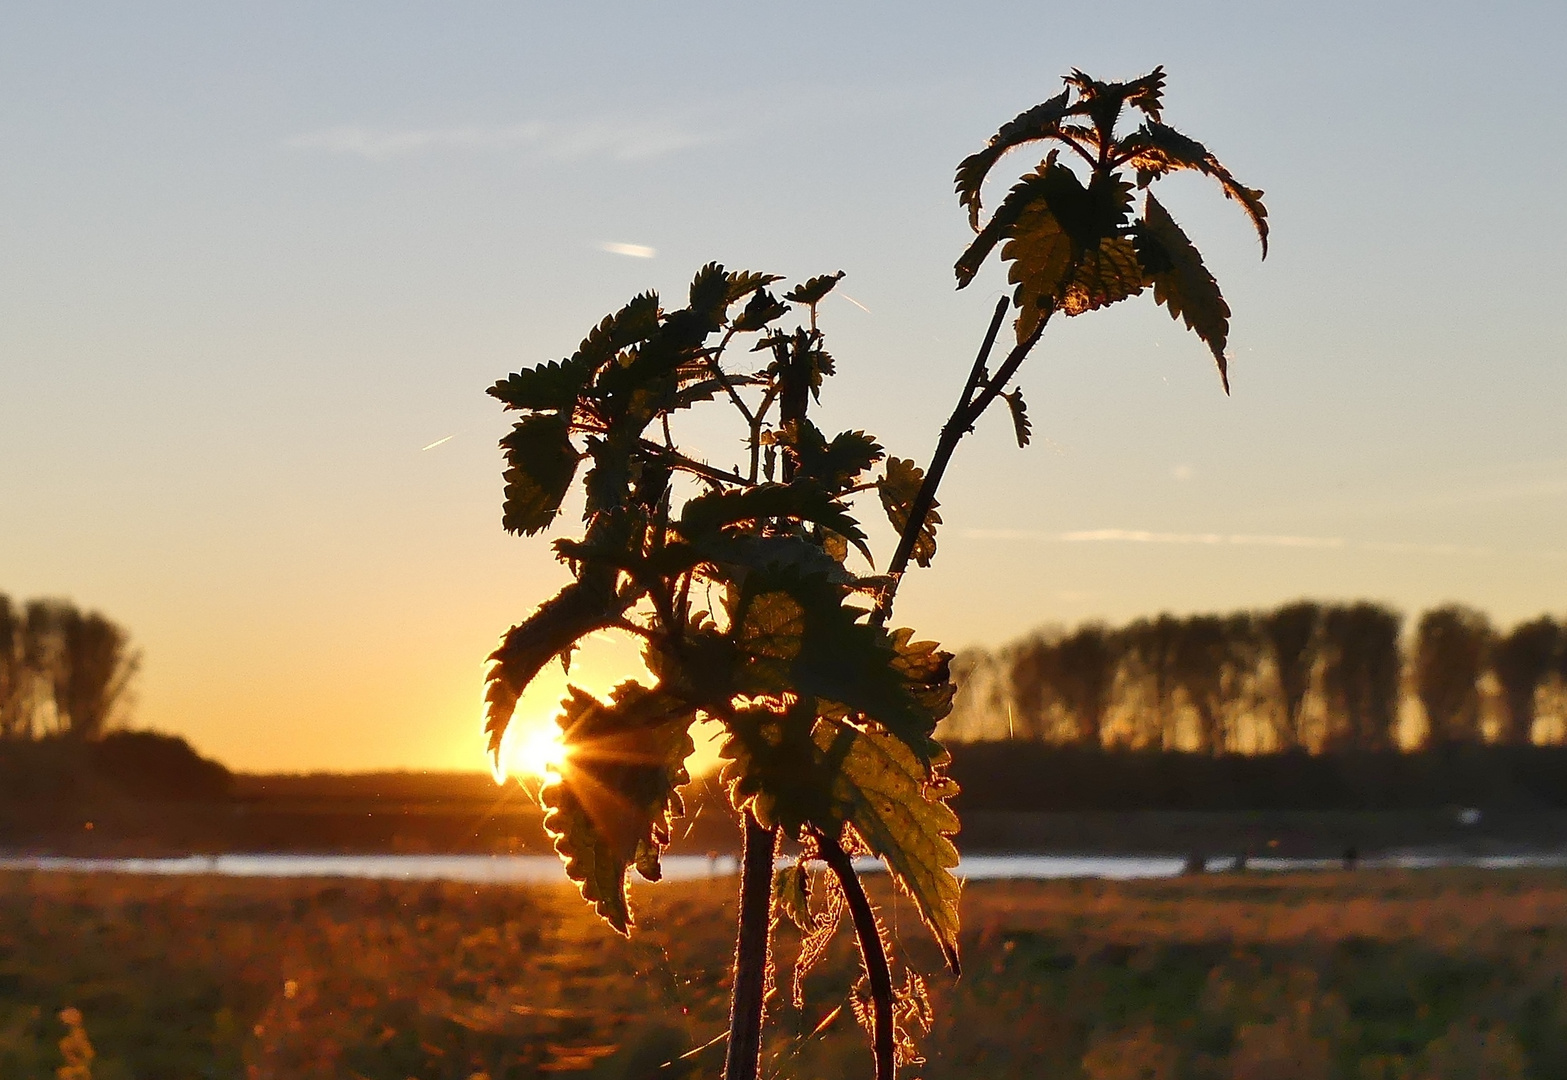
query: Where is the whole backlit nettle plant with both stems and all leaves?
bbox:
[486,69,1268,1080]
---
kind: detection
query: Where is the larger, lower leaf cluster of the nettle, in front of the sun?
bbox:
[486,263,957,959]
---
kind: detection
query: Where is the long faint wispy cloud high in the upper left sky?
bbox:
[284,119,713,161]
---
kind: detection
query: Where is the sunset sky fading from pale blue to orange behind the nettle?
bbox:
[0,0,1567,771]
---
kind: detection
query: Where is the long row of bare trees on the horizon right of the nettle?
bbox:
[943,600,1567,754]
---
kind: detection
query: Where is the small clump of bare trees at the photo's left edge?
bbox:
[0,593,141,741]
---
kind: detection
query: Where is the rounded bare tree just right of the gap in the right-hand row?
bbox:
[1413,603,1495,745]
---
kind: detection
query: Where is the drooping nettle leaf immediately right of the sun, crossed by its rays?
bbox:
[539,682,696,934]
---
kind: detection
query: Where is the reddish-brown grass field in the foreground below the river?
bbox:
[0,872,1567,1080]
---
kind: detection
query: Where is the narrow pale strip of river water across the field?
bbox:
[9,851,1567,884]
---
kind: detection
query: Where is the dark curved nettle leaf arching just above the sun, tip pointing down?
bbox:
[484,577,625,756]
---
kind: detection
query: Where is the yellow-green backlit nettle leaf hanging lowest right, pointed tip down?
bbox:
[813,721,962,972]
